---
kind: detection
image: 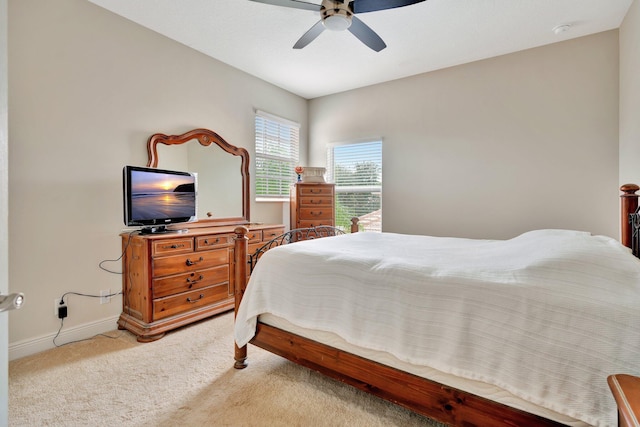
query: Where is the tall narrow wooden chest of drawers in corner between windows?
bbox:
[290,182,336,229]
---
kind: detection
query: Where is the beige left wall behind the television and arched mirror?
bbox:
[8,0,307,357]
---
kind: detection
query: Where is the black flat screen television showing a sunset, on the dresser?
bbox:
[122,166,198,234]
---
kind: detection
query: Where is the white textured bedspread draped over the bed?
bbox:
[235,230,640,426]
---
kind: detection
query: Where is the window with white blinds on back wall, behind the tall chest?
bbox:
[327,141,382,232]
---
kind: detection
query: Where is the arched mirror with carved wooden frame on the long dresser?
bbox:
[147,129,249,225]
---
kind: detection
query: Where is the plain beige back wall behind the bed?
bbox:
[309,30,620,238]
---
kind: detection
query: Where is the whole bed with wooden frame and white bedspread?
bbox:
[235,185,640,426]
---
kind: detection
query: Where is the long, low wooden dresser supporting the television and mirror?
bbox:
[118,224,284,342]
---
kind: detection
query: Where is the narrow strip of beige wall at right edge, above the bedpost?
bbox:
[620,0,640,184]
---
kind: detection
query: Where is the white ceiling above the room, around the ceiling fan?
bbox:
[89,0,633,99]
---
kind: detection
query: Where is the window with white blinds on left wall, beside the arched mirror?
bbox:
[255,111,300,200]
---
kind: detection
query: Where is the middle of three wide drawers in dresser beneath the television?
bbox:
[153,264,229,298]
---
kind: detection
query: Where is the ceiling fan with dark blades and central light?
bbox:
[251,0,425,52]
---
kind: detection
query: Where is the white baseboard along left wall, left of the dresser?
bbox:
[9,316,118,360]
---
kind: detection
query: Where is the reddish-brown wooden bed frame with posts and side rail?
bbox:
[234,184,640,427]
